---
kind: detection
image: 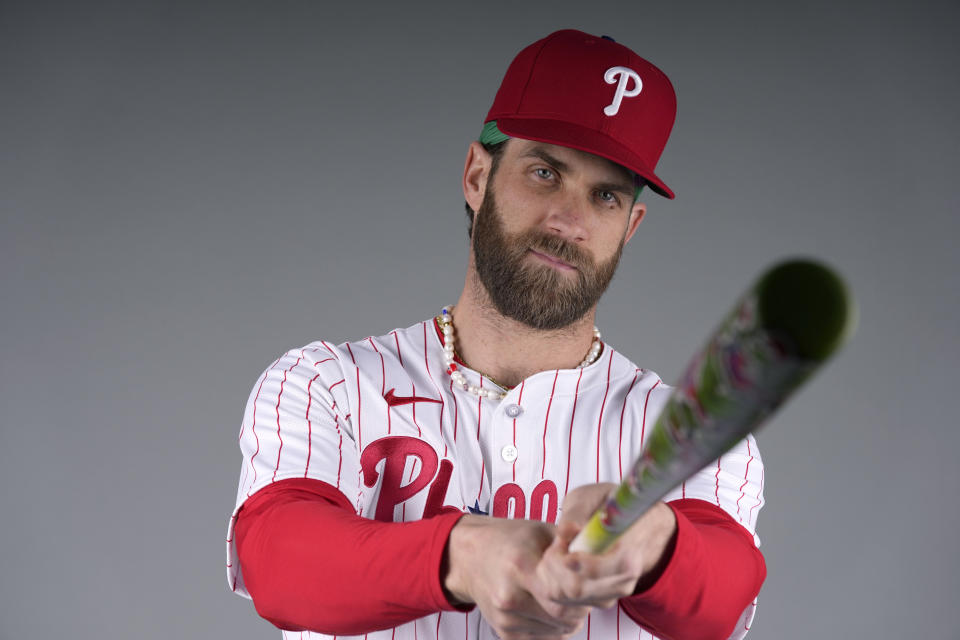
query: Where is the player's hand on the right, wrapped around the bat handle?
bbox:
[534,483,677,613]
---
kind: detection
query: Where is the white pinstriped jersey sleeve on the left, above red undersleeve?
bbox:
[227,343,360,598]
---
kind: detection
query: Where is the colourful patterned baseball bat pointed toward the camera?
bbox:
[570,259,857,553]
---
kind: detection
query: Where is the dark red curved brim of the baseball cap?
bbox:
[488,117,674,200]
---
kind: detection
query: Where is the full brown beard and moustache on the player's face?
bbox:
[472,184,623,330]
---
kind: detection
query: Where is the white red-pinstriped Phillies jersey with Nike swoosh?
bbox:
[227,320,763,640]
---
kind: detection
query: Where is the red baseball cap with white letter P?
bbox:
[484,29,677,198]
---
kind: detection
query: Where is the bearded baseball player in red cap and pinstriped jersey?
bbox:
[227,30,765,640]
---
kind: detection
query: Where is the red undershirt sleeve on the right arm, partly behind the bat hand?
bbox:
[620,499,767,640]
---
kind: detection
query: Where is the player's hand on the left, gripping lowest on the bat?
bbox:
[443,515,588,640]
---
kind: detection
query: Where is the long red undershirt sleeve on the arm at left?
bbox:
[235,479,463,635]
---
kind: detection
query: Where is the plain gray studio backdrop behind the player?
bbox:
[0,0,960,640]
